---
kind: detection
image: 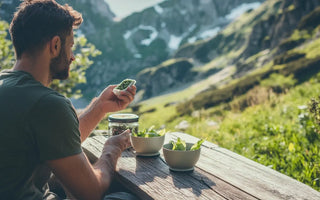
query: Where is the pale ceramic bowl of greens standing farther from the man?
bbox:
[163,143,201,171]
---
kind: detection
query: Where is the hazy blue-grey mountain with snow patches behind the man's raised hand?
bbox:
[83,0,262,98]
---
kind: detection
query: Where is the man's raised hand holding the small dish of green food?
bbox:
[98,85,136,113]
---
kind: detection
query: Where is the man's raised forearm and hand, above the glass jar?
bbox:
[79,85,136,142]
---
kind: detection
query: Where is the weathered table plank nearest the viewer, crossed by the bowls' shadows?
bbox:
[118,151,254,199]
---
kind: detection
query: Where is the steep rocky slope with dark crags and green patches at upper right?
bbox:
[137,0,319,98]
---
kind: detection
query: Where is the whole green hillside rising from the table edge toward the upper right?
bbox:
[98,0,320,191]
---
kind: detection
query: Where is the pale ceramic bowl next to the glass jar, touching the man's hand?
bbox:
[130,135,165,156]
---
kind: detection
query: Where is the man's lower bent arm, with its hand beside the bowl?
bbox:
[47,131,130,200]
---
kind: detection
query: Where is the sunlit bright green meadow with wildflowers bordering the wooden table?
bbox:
[97,58,320,191]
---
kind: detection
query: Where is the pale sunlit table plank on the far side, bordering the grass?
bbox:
[167,133,320,200]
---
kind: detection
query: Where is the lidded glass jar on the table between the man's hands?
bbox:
[108,113,139,136]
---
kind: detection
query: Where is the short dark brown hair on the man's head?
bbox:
[10,0,82,59]
